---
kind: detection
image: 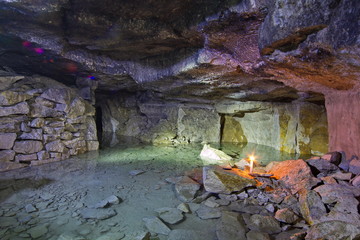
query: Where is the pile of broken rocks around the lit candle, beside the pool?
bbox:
[153,153,360,240]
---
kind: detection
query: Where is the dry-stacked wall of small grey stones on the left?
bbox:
[0,79,99,170]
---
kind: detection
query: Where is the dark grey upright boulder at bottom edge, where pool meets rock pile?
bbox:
[216,211,247,240]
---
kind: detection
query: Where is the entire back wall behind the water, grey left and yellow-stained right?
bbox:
[101,96,328,154]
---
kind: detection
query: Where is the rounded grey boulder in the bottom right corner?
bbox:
[305,221,360,240]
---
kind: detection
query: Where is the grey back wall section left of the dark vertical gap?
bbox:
[99,96,220,145]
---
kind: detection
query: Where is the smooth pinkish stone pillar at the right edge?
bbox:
[325,91,360,159]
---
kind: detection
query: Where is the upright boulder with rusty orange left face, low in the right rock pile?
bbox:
[299,188,326,225]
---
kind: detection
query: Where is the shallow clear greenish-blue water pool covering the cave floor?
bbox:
[0,144,308,240]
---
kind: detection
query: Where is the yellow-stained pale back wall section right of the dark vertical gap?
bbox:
[216,101,328,154]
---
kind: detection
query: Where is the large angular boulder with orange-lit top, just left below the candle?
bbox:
[203,166,256,194]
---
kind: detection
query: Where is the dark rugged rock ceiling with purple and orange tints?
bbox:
[0,0,360,102]
